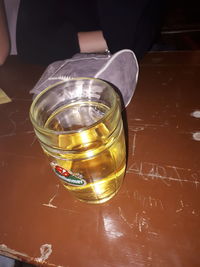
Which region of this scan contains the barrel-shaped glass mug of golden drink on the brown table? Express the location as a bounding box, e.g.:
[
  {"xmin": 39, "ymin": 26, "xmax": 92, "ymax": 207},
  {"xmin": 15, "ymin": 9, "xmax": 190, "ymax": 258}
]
[{"xmin": 30, "ymin": 78, "xmax": 126, "ymax": 203}]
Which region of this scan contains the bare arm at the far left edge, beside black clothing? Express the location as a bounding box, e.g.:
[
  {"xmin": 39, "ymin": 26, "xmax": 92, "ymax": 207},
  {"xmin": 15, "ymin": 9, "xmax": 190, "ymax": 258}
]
[{"xmin": 0, "ymin": 0, "xmax": 10, "ymax": 66}]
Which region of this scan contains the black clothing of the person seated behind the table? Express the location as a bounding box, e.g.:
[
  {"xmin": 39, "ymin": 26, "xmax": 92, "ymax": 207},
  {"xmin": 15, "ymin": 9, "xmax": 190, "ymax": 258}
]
[{"xmin": 17, "ymin": 0, "xmax": 165, "ymax": 64}]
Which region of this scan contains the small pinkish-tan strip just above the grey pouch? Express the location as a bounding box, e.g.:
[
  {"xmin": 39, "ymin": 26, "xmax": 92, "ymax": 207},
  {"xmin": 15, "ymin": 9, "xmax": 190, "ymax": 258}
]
[{"xmin": 78, "ymin": 31, "xmax": 108, "ymax": 53}]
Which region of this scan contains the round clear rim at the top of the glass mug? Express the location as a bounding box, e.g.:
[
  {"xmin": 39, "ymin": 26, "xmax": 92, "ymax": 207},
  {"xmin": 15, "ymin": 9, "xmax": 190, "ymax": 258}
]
[{"xmin": 29, "ymin": 77, "xmax": 117, "ymax": 135}]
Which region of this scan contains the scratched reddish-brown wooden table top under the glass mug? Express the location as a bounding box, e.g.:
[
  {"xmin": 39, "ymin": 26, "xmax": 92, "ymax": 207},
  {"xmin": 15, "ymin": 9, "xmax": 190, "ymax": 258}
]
[{"xmin": 0, "ymin": 51, "xmax": 200, "ymax": 267}]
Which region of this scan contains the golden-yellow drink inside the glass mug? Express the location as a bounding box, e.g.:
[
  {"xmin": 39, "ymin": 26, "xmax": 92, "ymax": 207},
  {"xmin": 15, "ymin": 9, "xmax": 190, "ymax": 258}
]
[{"xmin": 42, "ymin": 101, "xmax": 126, "ymax": 203}]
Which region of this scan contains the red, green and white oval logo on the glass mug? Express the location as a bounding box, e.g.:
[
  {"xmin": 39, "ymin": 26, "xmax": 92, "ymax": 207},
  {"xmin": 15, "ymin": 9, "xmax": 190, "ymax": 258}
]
[{"xmin": 51, "ymin": 163, "xmax": 86, "ymax": 186}]
